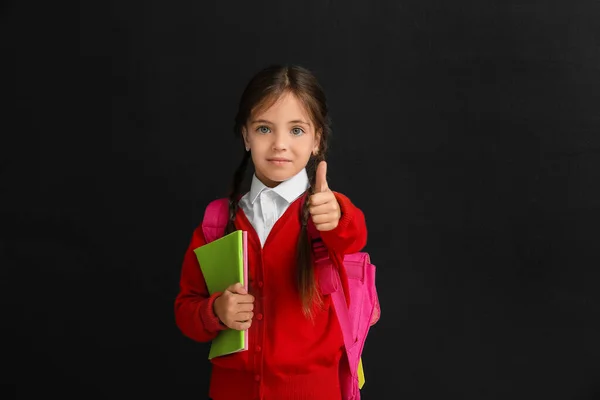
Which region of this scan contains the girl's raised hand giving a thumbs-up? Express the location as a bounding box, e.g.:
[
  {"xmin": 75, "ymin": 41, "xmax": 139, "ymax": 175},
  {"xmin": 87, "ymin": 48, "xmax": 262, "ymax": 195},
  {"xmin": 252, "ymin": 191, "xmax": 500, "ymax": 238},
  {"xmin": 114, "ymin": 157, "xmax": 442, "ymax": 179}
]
[{"xmin": 310, "ymin": 161, "xmax": 342, "ymax": 231}]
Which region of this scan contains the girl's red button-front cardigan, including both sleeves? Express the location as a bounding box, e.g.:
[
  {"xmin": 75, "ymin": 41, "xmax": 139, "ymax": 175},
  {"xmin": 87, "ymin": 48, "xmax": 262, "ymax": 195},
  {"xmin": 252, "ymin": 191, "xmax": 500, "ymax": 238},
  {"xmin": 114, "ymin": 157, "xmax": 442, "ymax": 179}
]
[{"xmin": 175, "ymin": 193, "xmax": 367, "ymax": 400}]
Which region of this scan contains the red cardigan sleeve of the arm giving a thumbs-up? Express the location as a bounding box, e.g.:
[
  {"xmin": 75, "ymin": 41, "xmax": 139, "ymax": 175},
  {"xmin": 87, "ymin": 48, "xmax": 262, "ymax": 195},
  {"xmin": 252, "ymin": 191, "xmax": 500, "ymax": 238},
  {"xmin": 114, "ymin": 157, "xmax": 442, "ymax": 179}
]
[{"xmin": 319, "ymin": 192, "xmax": 367, "ymax": 254}]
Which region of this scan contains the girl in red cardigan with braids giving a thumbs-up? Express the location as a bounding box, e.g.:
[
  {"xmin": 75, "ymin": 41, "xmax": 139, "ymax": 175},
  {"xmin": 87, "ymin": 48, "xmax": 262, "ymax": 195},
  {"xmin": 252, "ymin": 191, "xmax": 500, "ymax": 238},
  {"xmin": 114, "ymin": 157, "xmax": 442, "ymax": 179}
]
[{"xmin": 175, "ymin": 66, "xmax": 367, "ymax": 400}]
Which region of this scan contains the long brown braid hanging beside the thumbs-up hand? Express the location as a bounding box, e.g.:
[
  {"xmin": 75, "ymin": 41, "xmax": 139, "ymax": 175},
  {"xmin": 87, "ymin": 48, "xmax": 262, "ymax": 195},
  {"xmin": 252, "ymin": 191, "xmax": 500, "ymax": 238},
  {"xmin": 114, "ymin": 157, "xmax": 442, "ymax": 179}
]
[{"xmin": 297, "ymin": 153, "xmax": 323, "ymax": 318}]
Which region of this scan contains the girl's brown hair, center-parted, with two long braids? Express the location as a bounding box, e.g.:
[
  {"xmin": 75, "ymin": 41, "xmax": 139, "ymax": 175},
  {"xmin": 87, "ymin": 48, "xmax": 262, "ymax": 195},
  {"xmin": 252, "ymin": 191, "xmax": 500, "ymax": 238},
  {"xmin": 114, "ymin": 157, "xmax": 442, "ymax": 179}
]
[{"xmin": 226, "ymin": 65, "xmax": 331, "ymax": 317}]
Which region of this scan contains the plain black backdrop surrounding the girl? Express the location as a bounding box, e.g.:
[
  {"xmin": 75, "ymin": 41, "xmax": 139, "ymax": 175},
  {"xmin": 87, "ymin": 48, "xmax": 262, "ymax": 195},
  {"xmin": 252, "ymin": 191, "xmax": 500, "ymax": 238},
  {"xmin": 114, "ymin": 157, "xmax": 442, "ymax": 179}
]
[{"xmin": 0, "ymin": 0, "xmax": 600, "ymax": 399}]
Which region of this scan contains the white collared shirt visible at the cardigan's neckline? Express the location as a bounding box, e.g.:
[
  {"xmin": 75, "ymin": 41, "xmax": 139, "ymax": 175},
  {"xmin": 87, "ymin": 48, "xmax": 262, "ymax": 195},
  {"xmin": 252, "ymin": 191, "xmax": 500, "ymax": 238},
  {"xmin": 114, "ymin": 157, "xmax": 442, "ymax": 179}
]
[{"xmin": 239, "ymin": 169, "xmax": 309, "ymax": 246}]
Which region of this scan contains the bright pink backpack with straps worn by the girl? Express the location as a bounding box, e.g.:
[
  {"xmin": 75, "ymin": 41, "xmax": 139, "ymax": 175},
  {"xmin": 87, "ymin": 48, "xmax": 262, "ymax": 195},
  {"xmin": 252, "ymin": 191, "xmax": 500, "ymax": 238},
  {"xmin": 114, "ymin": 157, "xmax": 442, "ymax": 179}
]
[{"xmin": 202, "ymin": 198, "xmax": 381, "ymax": 400}]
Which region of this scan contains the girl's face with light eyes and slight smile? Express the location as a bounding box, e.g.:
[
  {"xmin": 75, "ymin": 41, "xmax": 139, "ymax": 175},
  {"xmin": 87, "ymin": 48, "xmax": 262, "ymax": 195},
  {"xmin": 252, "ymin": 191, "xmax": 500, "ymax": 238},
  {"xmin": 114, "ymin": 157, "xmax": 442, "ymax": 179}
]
[{"xmin": 242, "ymin": 93, "xmax": 319, "ymax": 187}]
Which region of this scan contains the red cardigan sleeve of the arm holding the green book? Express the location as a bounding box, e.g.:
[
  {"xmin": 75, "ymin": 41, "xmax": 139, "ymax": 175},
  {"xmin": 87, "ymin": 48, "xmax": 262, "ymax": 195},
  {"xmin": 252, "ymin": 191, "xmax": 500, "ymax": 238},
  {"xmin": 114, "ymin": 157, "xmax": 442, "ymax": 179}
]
[{"xmin": 175, "ymin": 226, "xmax": 227, "ymax": 342}]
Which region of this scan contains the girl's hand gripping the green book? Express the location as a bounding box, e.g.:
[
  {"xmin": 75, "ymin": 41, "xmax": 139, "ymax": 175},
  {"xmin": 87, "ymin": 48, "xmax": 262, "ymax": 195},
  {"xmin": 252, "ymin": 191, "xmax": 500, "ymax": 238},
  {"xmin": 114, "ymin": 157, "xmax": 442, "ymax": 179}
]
[{"xmin": 213, "ymin": 283, "xmax": 254, "ymax": 331}]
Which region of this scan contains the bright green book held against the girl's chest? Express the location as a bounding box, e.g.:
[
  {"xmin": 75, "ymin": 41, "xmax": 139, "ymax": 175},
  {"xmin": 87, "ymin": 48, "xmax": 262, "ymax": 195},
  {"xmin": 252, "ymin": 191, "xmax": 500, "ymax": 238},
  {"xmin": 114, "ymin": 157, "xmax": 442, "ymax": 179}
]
[{"xmin": 194, "ymin": 230, "xmax": 248, "ymax": 360}]
